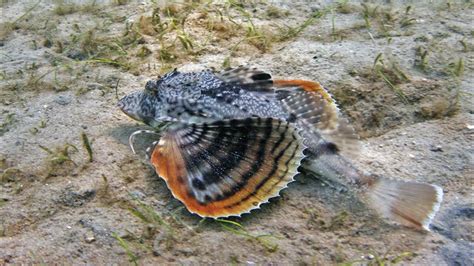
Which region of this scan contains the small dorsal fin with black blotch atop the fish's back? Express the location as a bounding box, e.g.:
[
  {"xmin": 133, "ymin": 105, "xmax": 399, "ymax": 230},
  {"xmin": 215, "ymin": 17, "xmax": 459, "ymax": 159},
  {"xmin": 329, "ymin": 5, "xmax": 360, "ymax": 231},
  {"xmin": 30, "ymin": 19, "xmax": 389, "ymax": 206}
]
[{"xmin": 216, "ymin": 66, "xmax": 273, "ymax": 91}]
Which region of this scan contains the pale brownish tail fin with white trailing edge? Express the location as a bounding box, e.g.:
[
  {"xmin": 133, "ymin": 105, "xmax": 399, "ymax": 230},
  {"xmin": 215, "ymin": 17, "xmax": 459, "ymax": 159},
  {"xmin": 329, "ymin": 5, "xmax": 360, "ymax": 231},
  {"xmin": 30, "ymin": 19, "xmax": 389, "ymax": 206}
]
[{"xmin": 368, "ymin": 178, "xmax": 443, "ymax": 231}]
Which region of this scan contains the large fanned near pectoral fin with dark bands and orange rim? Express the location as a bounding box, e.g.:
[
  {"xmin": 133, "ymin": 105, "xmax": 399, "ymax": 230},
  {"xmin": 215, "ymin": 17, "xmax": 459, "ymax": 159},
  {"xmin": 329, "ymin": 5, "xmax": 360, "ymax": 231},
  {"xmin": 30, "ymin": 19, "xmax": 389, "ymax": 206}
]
[{"xmin": 150, "ymin": 118, "xmax": 304, "ymax": 218}]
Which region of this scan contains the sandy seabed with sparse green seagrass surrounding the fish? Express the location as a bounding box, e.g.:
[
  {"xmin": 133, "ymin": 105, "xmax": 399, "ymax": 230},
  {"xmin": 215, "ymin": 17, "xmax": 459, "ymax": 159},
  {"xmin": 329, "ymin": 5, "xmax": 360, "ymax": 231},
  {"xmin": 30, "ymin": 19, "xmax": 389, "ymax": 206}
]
[{"xmin": 0, "ymin": 1, "xmax": 474, "ymax": 265}]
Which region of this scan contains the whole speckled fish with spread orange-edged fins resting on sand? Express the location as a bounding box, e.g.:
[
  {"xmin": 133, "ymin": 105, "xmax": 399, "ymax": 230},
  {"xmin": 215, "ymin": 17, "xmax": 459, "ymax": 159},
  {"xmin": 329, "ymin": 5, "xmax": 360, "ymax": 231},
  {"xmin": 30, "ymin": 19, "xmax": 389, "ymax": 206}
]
[{"xmin": 118, "ymin": 66, "xmax": 443, "ymax": 231}]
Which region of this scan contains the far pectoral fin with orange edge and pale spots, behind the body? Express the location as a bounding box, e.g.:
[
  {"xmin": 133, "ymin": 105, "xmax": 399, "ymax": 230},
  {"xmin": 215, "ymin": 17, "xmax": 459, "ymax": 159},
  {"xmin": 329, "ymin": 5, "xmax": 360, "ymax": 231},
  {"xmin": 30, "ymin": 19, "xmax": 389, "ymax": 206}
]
[{"xmin": 274, "ymin": 80, "xmax": 359, "ymax": 157}]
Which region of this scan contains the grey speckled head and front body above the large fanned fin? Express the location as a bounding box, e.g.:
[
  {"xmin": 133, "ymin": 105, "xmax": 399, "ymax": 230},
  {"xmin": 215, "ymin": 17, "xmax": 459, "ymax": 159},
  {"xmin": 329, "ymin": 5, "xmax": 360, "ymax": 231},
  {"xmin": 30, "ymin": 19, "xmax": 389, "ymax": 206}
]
[{"xmin": 119, "ymin": 70, "xmax": 287, "ymax": 126}]
